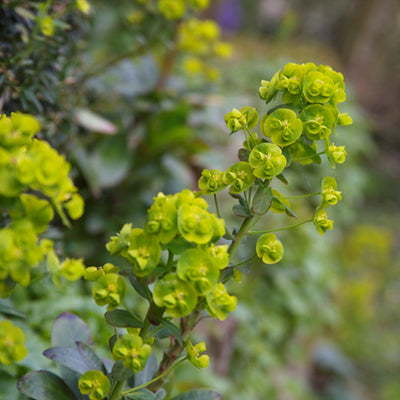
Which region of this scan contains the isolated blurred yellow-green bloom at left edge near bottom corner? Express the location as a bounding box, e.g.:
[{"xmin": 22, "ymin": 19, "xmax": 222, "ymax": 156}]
[{"xmin": 0, "ymin": 320, "xmax": 28, "ymax": 364}]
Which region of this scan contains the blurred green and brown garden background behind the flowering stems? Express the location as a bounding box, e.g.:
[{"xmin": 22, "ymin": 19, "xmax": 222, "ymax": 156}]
[{"xmin": 0, "ymin": 0, "xmax": 400, "ymax": 400}]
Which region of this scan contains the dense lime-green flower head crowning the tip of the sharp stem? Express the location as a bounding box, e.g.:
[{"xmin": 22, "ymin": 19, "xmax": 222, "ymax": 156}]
[{"xmin": 259, "ymin": 63, "xmax": 352, "ymax": 166}]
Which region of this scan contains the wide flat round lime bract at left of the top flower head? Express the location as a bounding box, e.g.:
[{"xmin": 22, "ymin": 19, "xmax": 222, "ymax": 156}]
[{"xmin": 260, "ymin": 108, "xmax": 303, "ymax": 147}]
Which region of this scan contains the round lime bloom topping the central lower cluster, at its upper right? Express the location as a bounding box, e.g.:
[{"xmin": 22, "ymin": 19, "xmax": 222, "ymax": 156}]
[{"xmin": 178, "ymin": 205, "xmax": 215, "ymax": 244}]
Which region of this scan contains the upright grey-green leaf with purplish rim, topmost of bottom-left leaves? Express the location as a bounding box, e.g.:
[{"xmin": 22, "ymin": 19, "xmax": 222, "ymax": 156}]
[{"xmin": 51, "ymin": 312, "xmax": 93, "ymax": 347}]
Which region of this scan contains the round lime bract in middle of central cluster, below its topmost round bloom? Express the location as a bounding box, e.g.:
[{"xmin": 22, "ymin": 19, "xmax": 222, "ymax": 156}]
[{"xmin": 176, "ymin": 249, "xmax": 219, "ymax": 296}]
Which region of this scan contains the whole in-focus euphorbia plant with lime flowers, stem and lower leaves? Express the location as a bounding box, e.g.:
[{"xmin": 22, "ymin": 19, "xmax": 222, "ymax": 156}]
[{"xmin": 19, "ymin": 63, "xmax": 351, "ymax": 400}]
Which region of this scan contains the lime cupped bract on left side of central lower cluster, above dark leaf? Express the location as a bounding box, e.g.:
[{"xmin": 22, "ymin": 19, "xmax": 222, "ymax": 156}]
[{"xmin": 126, "ymin": 228, "xmax": 161, "ymax": 277}]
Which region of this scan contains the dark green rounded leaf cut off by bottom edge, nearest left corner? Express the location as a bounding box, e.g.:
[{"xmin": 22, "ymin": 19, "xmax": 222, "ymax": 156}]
[{"xmin": 17, "ymin": 371, "xmax": 76, "ymax": 400}]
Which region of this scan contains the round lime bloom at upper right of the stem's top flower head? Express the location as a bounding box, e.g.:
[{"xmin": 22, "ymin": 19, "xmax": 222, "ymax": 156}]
[{"xmin": 303, "ymin": 71, "xmax": 336, "ymax": 103}]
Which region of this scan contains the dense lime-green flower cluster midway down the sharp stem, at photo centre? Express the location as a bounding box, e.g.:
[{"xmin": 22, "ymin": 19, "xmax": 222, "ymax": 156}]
[{"xmin": 106, "ymin": 190, "xmax": 236, "ymax": 319}]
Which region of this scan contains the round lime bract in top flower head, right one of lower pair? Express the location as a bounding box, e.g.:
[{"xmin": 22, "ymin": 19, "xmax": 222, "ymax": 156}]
[{"xmin": 299, "ymin": 104, "xmax": 335, "ymax": 140}]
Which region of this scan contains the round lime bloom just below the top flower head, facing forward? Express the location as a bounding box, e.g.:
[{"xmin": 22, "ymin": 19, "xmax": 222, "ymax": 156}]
[{"xmin": 249, "ymin": 143, "xmax": 286, "ymax": 179}]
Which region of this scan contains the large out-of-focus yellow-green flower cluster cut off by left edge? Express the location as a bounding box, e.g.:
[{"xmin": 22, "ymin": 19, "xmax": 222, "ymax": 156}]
[{"xmin": 0, "ymin": 113, "xmax": 83, "ymax": 297}]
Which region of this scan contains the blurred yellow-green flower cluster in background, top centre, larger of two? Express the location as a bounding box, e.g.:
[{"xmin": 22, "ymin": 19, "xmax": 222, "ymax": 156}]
[{"xmin": 178, "ymin": 18, "xmax": 232, "ymax": 80}]
